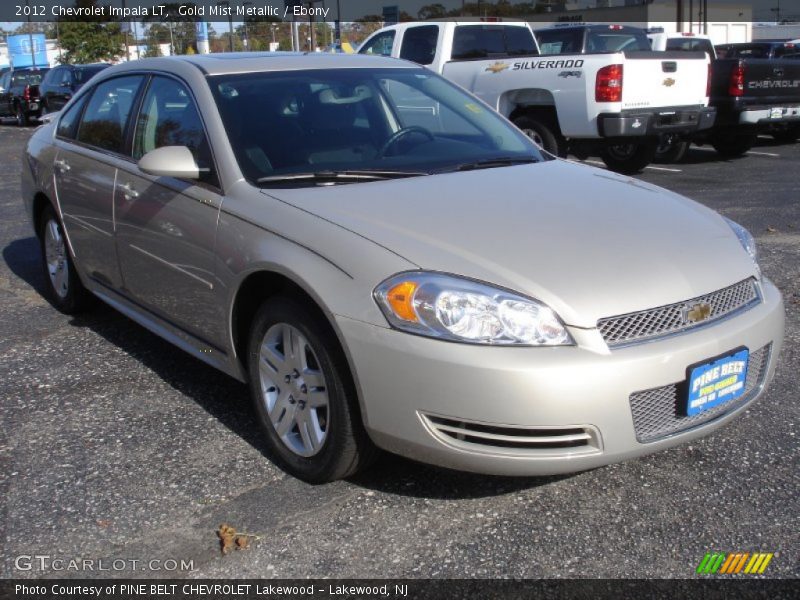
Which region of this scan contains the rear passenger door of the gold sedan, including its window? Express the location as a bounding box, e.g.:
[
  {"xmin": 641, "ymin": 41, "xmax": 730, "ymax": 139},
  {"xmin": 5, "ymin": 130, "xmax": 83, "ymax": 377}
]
[{"xmin": 53, "ymin": 75, "xmax": 144, "ymax": 289}]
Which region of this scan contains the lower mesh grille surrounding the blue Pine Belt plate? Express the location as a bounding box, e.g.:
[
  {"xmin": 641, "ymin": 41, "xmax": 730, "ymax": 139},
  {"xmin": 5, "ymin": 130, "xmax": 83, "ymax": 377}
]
[{"xmin": 630, "ymin": 344, "xmax": 771, "ymax": 442}]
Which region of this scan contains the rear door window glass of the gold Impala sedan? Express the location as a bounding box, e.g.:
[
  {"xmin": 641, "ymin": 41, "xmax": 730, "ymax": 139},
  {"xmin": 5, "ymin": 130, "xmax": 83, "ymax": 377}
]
[{"xmin": 76, "ymin": 75, "xmax": 143, "ymax": 154}]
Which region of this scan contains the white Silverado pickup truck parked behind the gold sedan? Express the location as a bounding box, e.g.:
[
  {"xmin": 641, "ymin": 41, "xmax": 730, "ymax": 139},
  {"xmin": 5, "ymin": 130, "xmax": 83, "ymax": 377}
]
[{"xmin": 359, "ymin": 21, "xmax": 715, "ymax": 173}]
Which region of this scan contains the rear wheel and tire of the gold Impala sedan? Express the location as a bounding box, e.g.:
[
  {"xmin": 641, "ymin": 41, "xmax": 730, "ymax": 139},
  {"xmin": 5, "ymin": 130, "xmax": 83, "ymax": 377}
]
[{"xmin": 39, "ymin": 205, "xmax": 93, "ymax": 315}]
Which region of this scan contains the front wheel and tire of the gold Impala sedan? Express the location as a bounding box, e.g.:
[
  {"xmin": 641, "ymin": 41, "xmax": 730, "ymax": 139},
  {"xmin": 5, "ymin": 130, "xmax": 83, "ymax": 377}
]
[{"xmin": 247, "ymin": 297, "xmax": 377, "ymax": 483}]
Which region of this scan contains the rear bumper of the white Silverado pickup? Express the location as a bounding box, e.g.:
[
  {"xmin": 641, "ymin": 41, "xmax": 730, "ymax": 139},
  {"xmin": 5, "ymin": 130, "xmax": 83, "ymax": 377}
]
[{"xmin": 597, "ymin": 107, "xmax": 717, "ymax": 138}]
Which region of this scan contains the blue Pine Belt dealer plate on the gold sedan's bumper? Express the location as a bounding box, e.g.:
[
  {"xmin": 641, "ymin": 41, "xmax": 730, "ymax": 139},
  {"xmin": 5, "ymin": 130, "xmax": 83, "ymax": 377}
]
[{"xmin": 686, "ymin": 348, "xmax": 749, "ymax": 417}]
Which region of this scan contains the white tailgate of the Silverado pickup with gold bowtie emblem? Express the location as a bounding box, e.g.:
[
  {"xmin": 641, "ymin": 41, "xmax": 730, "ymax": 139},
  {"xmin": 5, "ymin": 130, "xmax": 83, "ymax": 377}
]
[{"xmin": 622, "ymin": 52, "xmax": 709, "ymax": 110}]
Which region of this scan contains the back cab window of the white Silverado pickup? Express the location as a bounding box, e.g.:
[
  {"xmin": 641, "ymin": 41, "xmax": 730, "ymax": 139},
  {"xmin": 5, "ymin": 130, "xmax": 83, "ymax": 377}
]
[{"xmin": 452, "ymin": 25, "xmax": 538, "ymax": 60}]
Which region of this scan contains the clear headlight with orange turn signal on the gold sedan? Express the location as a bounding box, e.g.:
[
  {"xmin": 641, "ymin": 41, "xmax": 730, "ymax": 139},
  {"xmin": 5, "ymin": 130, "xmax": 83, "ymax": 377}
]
[{"xmin": 375, "ymin": 272, "xmax": 574, "ymax": 346}]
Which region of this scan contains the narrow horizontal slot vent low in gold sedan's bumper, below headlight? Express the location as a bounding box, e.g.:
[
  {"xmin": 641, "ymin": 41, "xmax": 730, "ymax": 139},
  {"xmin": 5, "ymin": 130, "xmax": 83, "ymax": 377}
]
[{"xmin": 421, "ymin": 414, "xmax": 600, "ymax": 453}]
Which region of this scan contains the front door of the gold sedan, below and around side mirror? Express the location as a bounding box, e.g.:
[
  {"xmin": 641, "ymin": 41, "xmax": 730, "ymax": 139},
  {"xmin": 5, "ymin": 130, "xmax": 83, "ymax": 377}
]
[{"xmin": 114, "ymin": 75, "xmax": 225, "ymax": 347}]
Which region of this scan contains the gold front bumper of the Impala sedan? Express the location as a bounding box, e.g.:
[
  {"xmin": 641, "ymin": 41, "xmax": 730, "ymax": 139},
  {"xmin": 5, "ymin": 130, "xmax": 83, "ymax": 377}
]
[{"xmin": 337, "ymin": 280, "xmax": 784, "ymax": 475}]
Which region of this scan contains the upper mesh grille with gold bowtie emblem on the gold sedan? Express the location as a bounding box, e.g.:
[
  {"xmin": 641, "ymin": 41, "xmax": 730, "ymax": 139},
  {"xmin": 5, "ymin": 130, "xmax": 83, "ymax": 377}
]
[{"xmin": 597, "ymin": 278, "xmax": 760, "ymax": 347}]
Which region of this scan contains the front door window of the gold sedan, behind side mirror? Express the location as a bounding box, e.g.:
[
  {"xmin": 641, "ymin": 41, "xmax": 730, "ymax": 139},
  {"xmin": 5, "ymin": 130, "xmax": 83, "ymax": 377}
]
[{"xmin": 133, "ymin": 77, "xmax": 216, "ymax": 184}]
